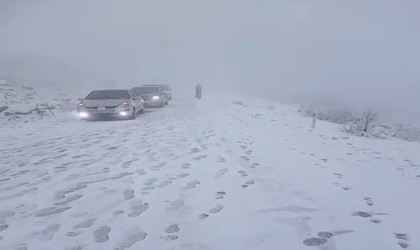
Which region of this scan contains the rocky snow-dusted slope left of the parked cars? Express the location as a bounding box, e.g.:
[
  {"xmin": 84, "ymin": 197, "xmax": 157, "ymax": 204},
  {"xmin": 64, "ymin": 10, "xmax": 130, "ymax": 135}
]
[{"xmin": 0, "ymin": 80, "xmax": 75, "ymax": 123}]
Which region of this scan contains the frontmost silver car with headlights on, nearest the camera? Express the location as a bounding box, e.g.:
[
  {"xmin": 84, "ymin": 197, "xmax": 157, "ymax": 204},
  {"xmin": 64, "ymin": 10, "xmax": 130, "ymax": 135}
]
[{"xmin": 77, "ymin": 90, "xmax": 144, "ymax": 120}]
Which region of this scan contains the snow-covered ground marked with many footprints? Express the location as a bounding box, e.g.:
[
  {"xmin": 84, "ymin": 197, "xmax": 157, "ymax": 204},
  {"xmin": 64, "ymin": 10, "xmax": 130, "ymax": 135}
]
[{"xmin": 0, "ymin": 95, "xmax": 420, "ymax": 250}]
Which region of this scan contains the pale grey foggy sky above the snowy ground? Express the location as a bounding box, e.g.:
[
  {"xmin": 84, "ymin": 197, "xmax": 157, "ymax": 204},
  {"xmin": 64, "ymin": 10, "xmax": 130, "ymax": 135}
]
[{"xmin": 0, "ymin": 0, "xmax": 420, "ymax": 122}]
